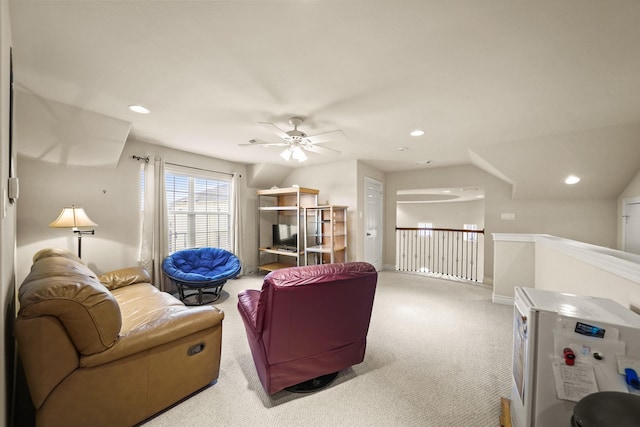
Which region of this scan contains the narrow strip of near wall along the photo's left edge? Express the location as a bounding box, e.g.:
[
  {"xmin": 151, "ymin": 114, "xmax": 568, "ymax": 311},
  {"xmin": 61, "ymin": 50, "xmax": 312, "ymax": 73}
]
[{"xmin": 0, "ymin": 1, "xmax": 18, "ymax": 424}]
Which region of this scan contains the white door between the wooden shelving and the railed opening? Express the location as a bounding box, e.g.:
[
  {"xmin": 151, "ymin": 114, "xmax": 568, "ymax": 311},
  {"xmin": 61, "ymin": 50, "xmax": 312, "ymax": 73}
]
[{"xmin": 364, "ymin": 176, "xmax": 382, "ymax": 271}]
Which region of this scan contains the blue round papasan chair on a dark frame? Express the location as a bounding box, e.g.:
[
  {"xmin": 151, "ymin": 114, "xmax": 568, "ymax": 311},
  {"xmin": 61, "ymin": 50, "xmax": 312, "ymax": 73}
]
[{"xmin": 162, "ymin": 248, "xmax": 242, "ymax": 305}]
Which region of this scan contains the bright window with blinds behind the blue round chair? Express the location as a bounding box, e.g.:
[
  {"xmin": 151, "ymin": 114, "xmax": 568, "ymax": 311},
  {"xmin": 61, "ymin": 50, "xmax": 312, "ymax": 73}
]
[{"xmin": 165, "ymin": 168, "xmax": 231, "ymax": 253}]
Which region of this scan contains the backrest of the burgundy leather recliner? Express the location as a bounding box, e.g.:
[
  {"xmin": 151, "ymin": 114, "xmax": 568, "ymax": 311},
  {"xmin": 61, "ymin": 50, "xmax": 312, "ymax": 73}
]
[{"xmin": 257, "ymin": 263, "xmax": 377, "ymax": 364}]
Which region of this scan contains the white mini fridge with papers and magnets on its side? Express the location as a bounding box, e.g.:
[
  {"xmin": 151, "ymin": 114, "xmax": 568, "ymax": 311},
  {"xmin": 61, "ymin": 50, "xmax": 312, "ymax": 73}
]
[{"xmin": 510, "ymin": 288, "xmax": 640, "ymax": 427}]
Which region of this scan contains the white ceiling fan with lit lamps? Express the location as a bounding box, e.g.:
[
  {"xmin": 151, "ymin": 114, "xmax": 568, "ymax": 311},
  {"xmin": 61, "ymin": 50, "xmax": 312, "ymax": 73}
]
[{"xmin": 239, "ymin": 117, "xmax": 344, "ymax": 162}]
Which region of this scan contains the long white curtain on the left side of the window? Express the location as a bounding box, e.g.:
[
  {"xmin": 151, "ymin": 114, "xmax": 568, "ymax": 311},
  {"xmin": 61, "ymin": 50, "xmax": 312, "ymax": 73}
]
[{"xmin": 140, "ymin": 157, "xmax": 169, "ymax": 291}]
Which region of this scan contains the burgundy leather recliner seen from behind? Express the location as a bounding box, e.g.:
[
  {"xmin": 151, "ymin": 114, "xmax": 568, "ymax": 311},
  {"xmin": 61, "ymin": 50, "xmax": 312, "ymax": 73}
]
[{"xmin": 238, "ymin": 262, "xmax": 378, "ymax": 394}]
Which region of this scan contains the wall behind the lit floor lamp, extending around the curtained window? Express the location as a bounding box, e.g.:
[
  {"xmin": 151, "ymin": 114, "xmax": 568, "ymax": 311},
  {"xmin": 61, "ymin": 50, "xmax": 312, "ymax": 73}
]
[{"xmin": 17, "ymin": 141, "xmax": 255, "ymax": 283}]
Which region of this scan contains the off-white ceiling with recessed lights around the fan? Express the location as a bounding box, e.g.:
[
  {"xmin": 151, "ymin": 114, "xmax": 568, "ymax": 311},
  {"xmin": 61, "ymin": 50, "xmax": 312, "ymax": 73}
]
[{"xmin": 9, "ymin": 0, "xmax": 640, "ymax": 199}]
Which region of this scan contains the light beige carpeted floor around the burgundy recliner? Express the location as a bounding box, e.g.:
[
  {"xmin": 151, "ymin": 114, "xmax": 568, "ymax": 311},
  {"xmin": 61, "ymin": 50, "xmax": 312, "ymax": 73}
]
[{"xmin": 144, "ymin": 272, "xmax": 513, "ymax": 427}]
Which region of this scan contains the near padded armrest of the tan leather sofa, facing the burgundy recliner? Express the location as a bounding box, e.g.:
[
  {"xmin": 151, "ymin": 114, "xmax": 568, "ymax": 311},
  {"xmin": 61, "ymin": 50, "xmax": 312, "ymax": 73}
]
[{"xmin": 80, "ymin": 306, "xmax": 224, "ymax": 367}]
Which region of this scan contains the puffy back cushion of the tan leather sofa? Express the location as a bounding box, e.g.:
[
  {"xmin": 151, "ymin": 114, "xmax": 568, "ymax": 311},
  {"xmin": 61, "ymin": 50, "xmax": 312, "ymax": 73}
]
[{"xmin": 18, "ymin": 249, "xmax": 122, "ymax": 355}]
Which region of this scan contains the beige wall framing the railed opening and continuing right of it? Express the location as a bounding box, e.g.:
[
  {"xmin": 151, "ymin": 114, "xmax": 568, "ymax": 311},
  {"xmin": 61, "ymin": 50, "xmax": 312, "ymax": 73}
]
[{"xmin": 384, "ymin": 165, "xmax": 617, "ymax": 283}]
